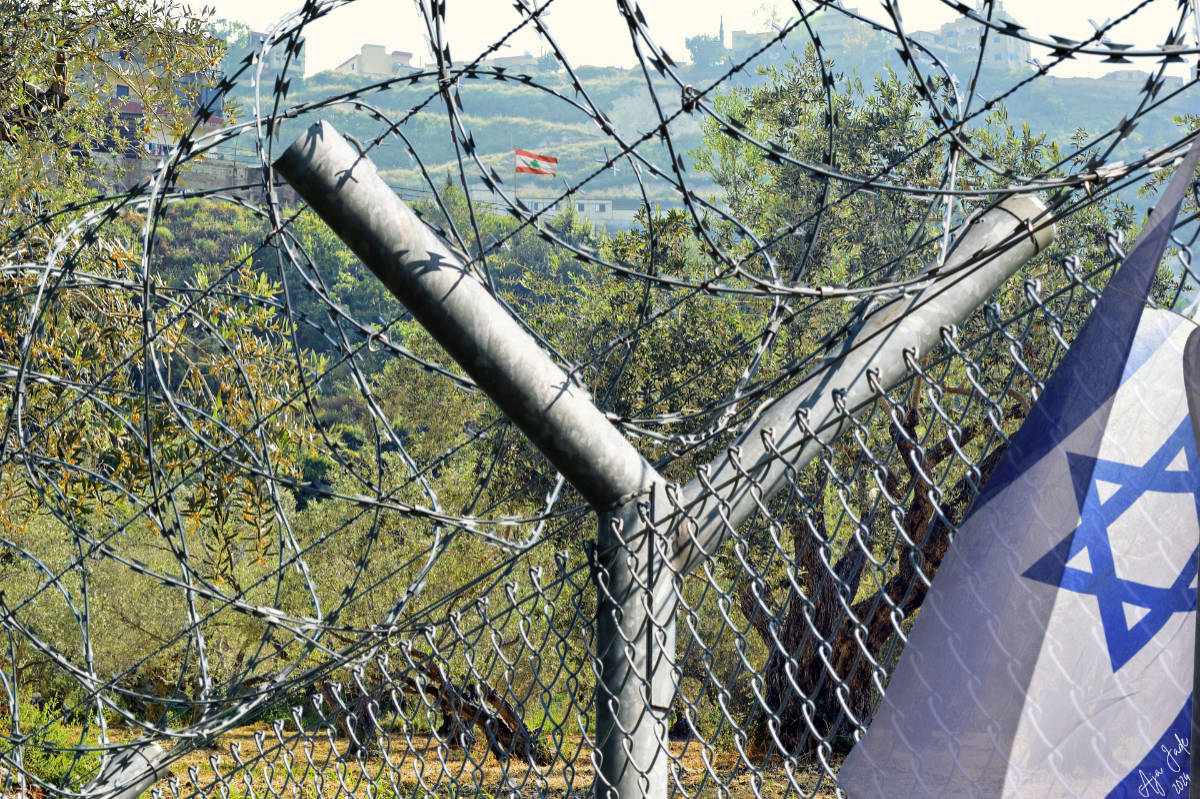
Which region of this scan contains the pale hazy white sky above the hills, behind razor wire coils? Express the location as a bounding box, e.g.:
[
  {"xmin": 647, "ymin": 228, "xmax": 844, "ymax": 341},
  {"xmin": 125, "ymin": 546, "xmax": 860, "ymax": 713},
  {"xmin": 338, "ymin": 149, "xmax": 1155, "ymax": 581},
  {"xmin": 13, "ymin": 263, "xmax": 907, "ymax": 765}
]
[{"xmin": 206, "ymin": 0, "xmax": 1195, "ymax": 76}]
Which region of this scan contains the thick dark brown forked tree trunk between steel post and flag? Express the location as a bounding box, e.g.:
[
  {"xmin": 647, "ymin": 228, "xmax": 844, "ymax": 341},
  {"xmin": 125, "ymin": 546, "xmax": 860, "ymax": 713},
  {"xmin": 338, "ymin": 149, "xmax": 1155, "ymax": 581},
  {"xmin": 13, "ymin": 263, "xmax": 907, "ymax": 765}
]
[{"xmin": 738, "ymin": 400, "xmax": 1019, "ymax": 758}]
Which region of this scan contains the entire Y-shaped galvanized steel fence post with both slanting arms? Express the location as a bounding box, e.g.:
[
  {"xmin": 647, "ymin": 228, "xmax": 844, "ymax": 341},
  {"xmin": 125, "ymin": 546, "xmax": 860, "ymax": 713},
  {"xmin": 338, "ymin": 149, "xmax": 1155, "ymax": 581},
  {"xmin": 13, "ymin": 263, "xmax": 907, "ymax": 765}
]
[{"xmin": 275, "ymin": 122, "xmax": 1054, "ymax": 799}]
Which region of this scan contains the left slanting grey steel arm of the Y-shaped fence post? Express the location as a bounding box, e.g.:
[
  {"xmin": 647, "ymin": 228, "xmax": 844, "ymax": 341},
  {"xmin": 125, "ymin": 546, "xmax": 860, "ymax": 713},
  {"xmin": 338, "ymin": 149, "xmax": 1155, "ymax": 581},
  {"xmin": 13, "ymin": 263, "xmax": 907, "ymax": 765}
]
[{"xmin": 275, "ymin": 122, "xmax": 660, "ymax": 509}]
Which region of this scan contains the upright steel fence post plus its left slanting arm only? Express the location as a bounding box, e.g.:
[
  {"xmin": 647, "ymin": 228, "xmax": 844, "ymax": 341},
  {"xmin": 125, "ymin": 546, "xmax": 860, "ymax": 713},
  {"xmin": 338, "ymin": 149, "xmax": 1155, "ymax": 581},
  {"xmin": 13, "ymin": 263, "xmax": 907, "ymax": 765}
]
[{"xmin": 275, "ymin": 122, "xmax": 674, "ymax": 799}]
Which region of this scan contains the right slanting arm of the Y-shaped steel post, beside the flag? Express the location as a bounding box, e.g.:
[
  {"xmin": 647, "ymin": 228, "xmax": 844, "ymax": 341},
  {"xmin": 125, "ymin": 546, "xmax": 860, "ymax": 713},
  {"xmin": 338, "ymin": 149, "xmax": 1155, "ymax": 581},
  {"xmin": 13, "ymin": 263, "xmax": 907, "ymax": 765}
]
[{"xmin": 673, "ymin": 194, "xmax": 1055, "ymax": 575}]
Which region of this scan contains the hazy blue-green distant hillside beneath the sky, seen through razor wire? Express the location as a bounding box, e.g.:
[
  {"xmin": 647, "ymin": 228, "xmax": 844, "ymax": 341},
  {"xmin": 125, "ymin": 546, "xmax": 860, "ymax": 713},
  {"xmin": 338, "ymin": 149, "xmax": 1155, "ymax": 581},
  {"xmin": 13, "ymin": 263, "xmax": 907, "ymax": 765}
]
[{"xmin": 213, "ymin": 14, "xmax": 1188, "ymax": 218}]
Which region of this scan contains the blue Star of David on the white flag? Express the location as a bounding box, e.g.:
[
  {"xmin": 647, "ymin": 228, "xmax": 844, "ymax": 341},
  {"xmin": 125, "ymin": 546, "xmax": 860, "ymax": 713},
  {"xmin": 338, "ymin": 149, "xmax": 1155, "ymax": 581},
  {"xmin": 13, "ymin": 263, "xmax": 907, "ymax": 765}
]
[{"xmin": 1022, "ymin": 417, "xmax": 1200, "ymax": 673}]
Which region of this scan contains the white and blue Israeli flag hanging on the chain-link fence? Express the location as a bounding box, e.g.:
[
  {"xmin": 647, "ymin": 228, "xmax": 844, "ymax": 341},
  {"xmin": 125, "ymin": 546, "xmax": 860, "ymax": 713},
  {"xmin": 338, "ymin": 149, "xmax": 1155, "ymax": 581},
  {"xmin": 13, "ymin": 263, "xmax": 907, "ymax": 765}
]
[{"xmin": 839, "ymin": 139, "xmax": 1200, "ymax": 799}]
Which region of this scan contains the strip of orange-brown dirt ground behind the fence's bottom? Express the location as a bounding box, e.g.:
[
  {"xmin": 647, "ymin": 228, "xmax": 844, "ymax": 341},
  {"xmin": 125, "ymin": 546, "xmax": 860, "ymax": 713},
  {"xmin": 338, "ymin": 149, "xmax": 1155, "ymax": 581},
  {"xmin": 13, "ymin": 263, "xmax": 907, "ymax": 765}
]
[{"xmin": 158, "ymin": 723, "xmax": 840, "ymax": 799}]
